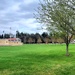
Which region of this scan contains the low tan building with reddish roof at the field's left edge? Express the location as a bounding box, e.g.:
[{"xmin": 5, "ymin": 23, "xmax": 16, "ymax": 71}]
[{"xmin": 0, "ymin": 38, "xmax": 23, "ymax": 46}]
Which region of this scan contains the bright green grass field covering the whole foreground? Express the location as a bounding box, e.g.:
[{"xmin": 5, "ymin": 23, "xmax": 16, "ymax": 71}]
[{"xmin": 0, "ymin": 44, "xmax": 75, "ymax": 75}]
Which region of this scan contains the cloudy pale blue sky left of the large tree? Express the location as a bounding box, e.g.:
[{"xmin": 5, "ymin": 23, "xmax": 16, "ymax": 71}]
[{"xmin": 0, "ymin": 0, "xmax": 45, "ymax": 33}]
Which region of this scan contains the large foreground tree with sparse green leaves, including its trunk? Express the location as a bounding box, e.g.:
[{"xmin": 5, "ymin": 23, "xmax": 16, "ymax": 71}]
[{"xmin": 35, "ymin": 0, "xmax": 75, "ymax": 56}]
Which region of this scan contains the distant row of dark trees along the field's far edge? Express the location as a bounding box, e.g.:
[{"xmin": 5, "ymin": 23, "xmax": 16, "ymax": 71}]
[{"xmin": 0, "ymin": 31, "xmax": 74, "ymax": 44}]
